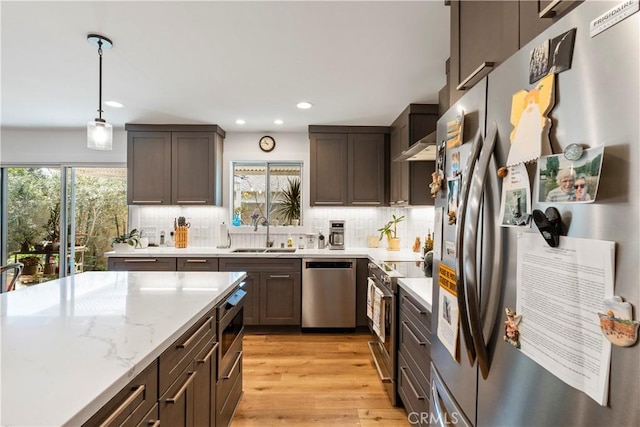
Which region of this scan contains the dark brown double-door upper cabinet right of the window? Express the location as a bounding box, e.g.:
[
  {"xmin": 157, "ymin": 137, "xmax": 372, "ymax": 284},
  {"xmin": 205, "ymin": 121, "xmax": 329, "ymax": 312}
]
[{"xmin": 309, "ymin": 126, "xmax": 389, "ymax": 206}]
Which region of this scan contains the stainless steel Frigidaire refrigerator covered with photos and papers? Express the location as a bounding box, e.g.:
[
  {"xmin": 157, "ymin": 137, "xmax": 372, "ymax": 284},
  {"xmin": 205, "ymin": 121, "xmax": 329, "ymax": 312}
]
[{"xmin": 431, "ymin": 1, "xmax": 640, "ymax": 426}]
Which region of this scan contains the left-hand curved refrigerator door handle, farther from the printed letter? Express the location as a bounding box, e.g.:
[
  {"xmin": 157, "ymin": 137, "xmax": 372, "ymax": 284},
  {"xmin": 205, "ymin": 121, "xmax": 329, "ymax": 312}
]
[{"xmin": 456, "ymin": 129, "xmax": 482, "ymax": 366}]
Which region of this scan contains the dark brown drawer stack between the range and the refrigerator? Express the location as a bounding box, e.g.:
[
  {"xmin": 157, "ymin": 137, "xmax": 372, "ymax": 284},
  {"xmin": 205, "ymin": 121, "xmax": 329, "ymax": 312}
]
[{"xmin": 398, "ymin": 288, "xmax": 431, "ymax": 426}]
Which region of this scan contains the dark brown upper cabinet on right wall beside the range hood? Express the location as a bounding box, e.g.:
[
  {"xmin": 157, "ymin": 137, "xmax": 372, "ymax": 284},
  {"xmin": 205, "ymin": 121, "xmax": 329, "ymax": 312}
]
[{"xmin": 389, "ymin": 104, "xmax": 438, "ymax": 206}]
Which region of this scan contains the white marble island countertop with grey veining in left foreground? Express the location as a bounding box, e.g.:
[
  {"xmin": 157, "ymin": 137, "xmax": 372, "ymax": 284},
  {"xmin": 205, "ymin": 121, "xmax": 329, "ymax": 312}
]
[{"xmin": 0, "ymin": 272, "xmax": 246, "ymax": 426}]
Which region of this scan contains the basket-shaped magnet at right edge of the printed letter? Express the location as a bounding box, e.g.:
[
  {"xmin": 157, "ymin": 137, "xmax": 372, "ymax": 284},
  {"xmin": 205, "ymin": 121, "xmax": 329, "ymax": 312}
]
[{"xmin": 598, "ymin": 296, "xmax": 640, "ymax": 347}]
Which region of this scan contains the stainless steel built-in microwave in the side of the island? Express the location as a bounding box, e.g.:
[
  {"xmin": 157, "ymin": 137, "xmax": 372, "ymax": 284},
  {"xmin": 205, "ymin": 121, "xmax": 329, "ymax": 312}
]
[{"xmin": 217, "ymin": 283, "xmax": 247, "ymax": 379}]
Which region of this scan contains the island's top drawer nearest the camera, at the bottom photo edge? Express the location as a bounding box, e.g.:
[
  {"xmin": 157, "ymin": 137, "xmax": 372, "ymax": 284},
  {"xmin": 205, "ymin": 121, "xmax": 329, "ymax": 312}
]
[{"xmin": 84, "ymin": 360, "xmax": 158, "ymax": 426}]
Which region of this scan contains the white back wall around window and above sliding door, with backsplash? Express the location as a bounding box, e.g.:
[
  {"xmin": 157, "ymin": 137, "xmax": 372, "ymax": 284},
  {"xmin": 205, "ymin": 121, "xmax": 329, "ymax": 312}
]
[{"xmin": 0, "ymin": 129, "xmax": 434, "ymax": 252}]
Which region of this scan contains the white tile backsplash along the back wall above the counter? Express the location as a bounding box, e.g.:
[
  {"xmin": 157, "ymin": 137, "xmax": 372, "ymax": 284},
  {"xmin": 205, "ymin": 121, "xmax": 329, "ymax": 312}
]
[{"xmin": 129, "ymin": 206, "xmax": 434, "ymax": 248}]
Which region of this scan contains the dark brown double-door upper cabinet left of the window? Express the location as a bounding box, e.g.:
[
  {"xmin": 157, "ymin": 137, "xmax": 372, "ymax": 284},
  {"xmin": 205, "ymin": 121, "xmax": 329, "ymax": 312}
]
[{"xmin": 125, "ymin": 124, "xmax": 225, "ymax": 205}]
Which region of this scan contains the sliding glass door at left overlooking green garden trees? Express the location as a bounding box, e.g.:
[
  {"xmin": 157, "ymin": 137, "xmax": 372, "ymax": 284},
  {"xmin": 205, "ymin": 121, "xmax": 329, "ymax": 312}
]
[{"xmin": 0, "ymin": 167, "xmax": 127, "ymax": 291}]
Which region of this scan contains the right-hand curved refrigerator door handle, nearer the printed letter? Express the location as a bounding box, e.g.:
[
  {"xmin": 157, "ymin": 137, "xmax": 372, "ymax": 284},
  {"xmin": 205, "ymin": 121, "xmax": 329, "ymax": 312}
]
[{"xmin": 461, "ymin": 122, "xmax": 498, "ymax": 379}]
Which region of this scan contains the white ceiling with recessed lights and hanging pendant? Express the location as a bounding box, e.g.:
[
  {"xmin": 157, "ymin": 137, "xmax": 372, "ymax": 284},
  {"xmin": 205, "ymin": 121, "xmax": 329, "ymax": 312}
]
[{"xmin": 0, "ymin": 0, "xmax": 449, "ymax": 132}]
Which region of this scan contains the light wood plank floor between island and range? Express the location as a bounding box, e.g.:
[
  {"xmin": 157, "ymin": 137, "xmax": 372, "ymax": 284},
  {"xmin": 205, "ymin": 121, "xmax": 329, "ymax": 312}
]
[{"xmin": 231, "ymin": 333, "xmax": 409, "ymax": 427}]
